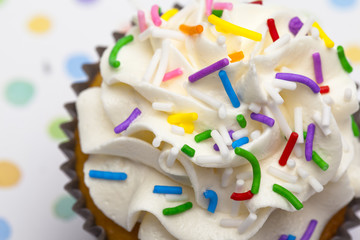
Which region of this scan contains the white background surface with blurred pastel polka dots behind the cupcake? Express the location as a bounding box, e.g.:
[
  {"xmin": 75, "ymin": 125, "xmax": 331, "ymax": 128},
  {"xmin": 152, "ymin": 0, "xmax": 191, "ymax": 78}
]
[{"xmin": 0, "ymin": 0, "xmax": 360, "ymax": 240}]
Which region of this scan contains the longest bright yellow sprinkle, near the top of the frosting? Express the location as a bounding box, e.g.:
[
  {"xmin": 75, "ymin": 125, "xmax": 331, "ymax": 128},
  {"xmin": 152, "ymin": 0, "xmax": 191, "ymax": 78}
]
[{"xmin": 208, "ymin": 14, "xmax": 262, "ymax": 41}]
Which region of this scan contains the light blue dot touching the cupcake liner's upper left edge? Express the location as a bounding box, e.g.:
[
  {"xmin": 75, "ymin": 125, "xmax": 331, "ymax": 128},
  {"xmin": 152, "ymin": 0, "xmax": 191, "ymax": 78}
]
[{"xmin": 66, "ymin": 54, "xmax": 92, "ymax": 82}]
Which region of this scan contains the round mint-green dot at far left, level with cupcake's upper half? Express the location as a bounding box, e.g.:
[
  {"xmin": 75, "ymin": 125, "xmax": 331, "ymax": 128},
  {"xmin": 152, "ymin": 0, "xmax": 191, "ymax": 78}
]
[{"xmin": 4, "ymin": 79, "xmax": 35, "ymax": 106}]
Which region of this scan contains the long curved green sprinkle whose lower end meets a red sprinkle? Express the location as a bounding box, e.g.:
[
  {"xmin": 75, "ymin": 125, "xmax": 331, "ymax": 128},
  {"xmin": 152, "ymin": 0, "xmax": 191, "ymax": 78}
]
[{"xmin": 235, "ymin": 147, "xmax": 261, "ymax": 194}]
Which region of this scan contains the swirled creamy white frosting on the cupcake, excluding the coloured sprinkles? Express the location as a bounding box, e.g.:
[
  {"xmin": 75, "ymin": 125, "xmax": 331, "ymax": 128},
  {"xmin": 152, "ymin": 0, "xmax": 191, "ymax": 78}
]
[{"xmin": 77, "ymin": 1, "xmax": 360, "ymax": 240}]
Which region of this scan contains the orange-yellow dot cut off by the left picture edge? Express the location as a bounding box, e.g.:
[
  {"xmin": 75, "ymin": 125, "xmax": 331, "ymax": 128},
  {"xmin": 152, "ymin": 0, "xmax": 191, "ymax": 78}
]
[{"xmin": 0, "ymin": 161, "xmax": 21, "ymax": 187}]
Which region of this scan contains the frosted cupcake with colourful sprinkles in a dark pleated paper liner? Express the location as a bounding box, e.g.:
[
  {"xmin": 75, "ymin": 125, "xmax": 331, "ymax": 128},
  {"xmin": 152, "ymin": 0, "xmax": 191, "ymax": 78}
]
[{"xmin": 62, "ymin": 1, "xmax": 360, "ymax": 240}]
